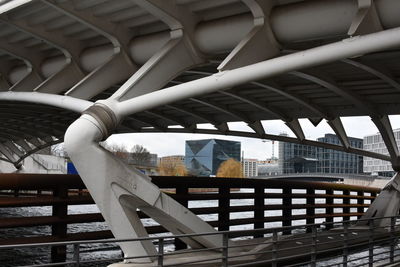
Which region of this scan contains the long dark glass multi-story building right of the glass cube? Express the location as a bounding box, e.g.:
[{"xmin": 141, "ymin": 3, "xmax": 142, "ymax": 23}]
[{"xmin": 279, "ymin": 134, "xmax": 363, "ymax": 173}]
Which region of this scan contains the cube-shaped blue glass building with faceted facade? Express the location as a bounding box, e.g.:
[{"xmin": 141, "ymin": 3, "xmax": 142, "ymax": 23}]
[{"xmin": 185, "ymin": 139, "xmax": 241, "ymax": 176}]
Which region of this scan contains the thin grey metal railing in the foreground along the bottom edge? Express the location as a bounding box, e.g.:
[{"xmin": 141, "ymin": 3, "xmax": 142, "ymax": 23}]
[{"xmin": 0, "ymin": 216, "xmax": 400, "ymax": 267}]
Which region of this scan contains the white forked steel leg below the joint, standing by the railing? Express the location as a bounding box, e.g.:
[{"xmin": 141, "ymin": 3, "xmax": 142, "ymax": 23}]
[{"xmin": 65, "ymin": 114, "xmax": 227, "ymax": 262}]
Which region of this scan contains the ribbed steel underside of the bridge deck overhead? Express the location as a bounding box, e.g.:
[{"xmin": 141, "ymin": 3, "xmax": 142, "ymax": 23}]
[{"xmin": 0, "ymin": 0, "xmax": 400, "ymax": 168}]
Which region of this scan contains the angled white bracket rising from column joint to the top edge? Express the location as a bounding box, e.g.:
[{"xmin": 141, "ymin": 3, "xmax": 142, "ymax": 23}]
[{"xmin": 112, "ymin": 0, "xmax": 205, "ymax": 101}]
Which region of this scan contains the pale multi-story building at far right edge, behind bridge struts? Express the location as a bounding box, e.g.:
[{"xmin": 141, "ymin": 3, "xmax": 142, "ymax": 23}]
[{"xmin": 364, "ymin": 129, "xmax": 400, "ymax": 177}]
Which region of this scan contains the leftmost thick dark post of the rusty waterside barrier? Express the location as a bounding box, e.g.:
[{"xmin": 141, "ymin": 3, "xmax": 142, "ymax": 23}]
[{"xmin": 51, "ymin": 186, "xmax": 68, "ymax": 262}]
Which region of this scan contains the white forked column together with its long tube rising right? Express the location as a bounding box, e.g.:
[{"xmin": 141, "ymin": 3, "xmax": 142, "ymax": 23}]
[{"xmin": 61, "ymin": 25, "xmax": 400, "ymax": 260}]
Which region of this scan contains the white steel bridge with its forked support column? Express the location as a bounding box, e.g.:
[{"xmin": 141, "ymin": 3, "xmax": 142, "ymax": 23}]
[{"xmin": 0, "ymin": 0, "xmax": 400, "ymax": 261}]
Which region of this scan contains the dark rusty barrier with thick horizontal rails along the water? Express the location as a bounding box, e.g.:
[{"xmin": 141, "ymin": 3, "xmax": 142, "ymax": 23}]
[{"xmin": 0, "ymin": 174, "xmax": 379, "ymax": 261}]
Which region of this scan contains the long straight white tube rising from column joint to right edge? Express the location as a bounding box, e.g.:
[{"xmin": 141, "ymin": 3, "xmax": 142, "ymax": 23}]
[{"xmin": 115, "ymin": 28, "xmax": 400, "ymax": 118}]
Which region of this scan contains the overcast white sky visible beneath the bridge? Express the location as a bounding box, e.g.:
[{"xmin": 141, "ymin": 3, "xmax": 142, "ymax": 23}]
[{"xmin": 107, "ymin": 115, "xmax": 400, "ymax": 160}]
